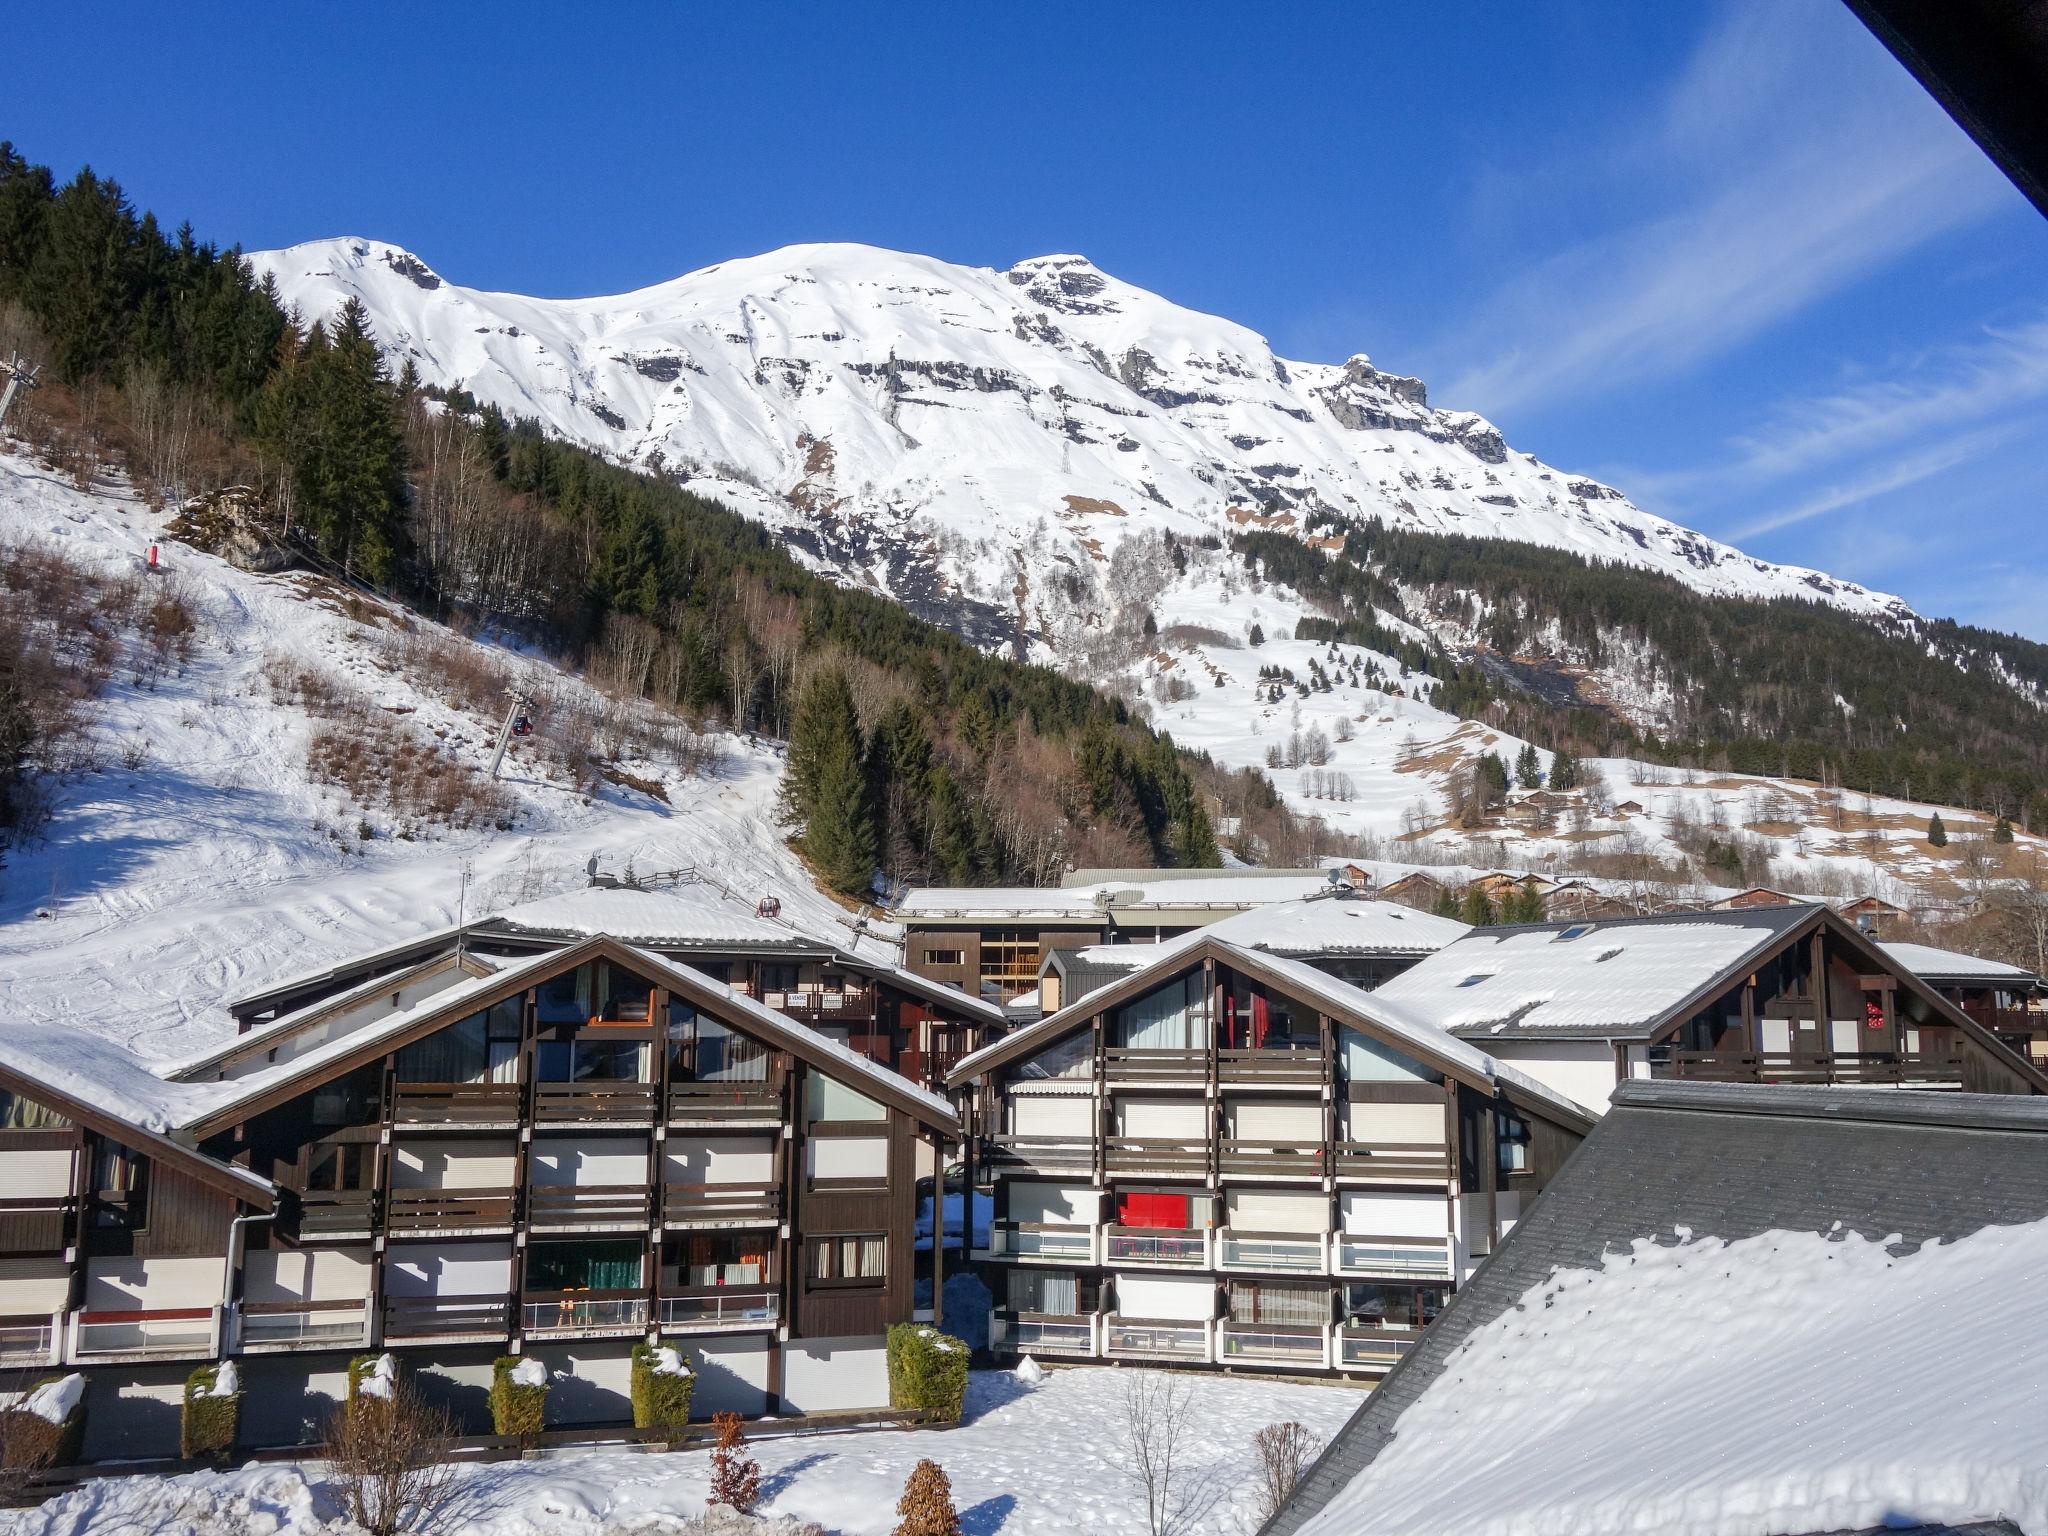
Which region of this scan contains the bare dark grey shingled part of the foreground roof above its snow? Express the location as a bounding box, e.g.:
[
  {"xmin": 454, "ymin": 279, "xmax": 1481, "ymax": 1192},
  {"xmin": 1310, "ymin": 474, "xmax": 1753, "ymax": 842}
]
[{"xmin": 1262, "ymin": 1081, "xmax": 2048, "ymax": 1536}]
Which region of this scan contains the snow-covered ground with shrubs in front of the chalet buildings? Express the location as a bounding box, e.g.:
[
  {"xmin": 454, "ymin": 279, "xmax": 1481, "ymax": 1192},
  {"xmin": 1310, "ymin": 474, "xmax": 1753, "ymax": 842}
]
[{"xmin": 0, "ymin": 1368, "xmax": 1364, "ymax": 1536}]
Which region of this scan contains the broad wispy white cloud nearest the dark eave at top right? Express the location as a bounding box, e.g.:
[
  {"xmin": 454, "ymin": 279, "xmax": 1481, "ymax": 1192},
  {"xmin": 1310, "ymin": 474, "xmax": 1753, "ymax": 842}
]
[{"xmin": 1444, "ymin": 0, "xmax": 2009, "ymax": 414}]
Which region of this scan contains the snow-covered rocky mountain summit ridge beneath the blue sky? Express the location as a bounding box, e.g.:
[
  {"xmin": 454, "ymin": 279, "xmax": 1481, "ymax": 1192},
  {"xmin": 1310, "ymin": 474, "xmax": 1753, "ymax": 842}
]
[{"xmin": 252, "ymin": 240, "xmax": 1907, "ymax": 664}]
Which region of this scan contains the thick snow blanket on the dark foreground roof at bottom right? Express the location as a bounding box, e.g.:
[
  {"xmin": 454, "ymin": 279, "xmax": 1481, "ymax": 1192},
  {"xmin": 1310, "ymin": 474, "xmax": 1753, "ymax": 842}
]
[{"xmin": 1300, "ymin": 1221, "xmax": 2048, "ymax": 1536}]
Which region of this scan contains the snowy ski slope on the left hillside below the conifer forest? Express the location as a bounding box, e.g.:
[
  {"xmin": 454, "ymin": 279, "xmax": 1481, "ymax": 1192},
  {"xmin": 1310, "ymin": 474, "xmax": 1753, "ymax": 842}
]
[{"xmin": 0, "ymin": 453, "xmax": 881, "ymax": 1059}]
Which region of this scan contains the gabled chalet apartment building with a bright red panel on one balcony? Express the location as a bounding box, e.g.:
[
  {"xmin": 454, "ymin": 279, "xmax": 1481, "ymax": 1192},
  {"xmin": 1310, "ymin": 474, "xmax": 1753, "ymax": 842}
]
[{"xmin": 950, "ymin": 933, "xmax": 1593, "ymax": 1376}]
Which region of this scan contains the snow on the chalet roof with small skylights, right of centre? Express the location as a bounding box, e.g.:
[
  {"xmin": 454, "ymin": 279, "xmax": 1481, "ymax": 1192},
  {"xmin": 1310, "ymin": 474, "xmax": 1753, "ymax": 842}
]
[{"xmin": 1372, "ymin": 922, "xmax": 1782, "ymax": 1034}]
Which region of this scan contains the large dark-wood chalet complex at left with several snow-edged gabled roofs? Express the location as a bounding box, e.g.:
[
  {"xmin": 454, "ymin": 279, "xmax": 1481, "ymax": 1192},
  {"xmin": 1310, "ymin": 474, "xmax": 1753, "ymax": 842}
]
[{"xmin": 0, "ymin": 889, "xmax": 993, "ymax": 1458}]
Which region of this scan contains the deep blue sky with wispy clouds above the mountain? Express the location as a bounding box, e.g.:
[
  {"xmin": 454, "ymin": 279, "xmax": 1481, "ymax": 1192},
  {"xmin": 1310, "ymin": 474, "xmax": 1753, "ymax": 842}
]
[{"xmin": 12, "ymin": 0, "xmax": 2048, "ymax": 639}]
